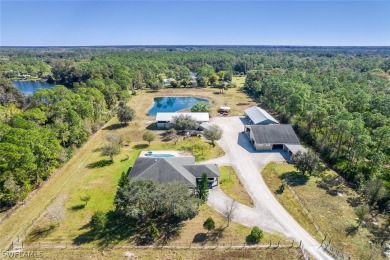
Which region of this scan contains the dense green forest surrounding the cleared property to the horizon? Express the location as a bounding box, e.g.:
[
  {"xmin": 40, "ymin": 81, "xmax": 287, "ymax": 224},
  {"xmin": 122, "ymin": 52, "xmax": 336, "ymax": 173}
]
[{"xmin": 0, "ymin": 46, "xmax": 390, "ymax": 213}]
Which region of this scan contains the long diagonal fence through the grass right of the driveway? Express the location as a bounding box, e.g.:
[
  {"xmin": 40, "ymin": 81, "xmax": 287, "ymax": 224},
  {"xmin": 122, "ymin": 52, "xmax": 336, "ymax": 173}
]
[{"xmin": 286, "ymin": 179, "xmax": 350, "ymax": 260}]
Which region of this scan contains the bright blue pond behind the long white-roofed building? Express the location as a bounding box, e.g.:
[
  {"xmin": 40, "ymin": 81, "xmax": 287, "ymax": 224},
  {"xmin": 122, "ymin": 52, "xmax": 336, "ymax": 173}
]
[{"xmin": 148, "ymin": 97, "xmax": 209, "ymax": 116}]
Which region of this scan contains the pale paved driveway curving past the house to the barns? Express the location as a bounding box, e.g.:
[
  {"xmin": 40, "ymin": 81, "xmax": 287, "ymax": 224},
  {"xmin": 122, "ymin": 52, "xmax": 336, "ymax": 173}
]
[{"xmin": 205, "ymin": 117, "xmax": 332, "ymax": 259}]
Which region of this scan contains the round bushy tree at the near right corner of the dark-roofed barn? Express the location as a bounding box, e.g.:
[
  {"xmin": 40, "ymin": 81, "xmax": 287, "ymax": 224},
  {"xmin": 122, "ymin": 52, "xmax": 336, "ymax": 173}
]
[{"xmin": 291, "ymin": 151, "xmax": 320, "ymax": 175}]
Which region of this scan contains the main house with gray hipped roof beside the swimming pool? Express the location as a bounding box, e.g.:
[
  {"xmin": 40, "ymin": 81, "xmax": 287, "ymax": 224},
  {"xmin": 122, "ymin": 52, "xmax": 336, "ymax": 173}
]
[{"xmin": 128, "ymin": 156, "xmax": 219, "ymax": 188}]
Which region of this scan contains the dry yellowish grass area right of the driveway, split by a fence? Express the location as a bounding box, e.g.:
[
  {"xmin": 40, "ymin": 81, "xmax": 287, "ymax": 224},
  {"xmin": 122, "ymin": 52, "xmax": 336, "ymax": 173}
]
[{"xmin": 262, "ymin": 163, "xmax": 372, "ymax": 259}]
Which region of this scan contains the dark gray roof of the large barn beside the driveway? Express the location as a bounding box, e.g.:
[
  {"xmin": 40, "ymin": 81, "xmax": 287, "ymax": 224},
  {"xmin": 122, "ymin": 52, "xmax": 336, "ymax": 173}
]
[{"xmin": 250, "ymin": 125, "xmax": 299, "ymax": 144}]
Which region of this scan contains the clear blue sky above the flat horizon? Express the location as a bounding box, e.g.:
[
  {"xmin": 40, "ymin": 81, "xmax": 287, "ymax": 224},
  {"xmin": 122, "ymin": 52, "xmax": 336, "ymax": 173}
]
[{"xmin": 0, "ymin": 0, "xmax": 390, "ymax": 46}]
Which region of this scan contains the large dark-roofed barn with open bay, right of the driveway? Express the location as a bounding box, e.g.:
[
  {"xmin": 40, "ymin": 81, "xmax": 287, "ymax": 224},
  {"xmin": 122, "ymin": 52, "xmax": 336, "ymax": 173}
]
[{"xmin": 245, "ymin": 124, "xmax": 306, "ymax": 155}]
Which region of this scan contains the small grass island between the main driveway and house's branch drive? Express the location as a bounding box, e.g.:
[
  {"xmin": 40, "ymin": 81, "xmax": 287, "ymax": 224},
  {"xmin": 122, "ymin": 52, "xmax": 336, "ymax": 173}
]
[{"xmin": 219, "ymin": 166, "xmax": 254, "ymax": 207}]
